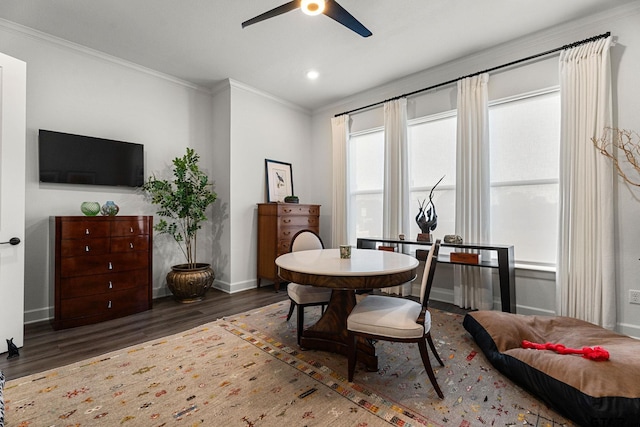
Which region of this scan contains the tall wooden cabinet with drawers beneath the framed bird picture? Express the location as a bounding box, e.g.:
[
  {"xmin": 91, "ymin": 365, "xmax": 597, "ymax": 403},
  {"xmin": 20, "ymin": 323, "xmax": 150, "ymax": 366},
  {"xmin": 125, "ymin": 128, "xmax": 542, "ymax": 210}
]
[{"xmin": 258, "ymin": 203, "xmax": 320, "ymax": 291}]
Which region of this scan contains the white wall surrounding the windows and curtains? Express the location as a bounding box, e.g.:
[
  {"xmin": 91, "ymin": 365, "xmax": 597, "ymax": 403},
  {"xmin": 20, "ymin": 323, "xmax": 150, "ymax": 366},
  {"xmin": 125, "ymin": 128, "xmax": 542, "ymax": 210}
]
[{"xmin": 311, "ymin": 3, "xmax": 640, "ymax": 337}]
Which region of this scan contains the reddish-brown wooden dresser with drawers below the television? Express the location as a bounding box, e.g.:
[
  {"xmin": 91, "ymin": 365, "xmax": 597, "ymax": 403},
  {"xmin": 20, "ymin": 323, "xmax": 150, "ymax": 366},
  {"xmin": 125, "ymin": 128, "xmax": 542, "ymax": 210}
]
[{"xmin": 49, "ymin": 216, "xmax": 153, "ymax": 329}]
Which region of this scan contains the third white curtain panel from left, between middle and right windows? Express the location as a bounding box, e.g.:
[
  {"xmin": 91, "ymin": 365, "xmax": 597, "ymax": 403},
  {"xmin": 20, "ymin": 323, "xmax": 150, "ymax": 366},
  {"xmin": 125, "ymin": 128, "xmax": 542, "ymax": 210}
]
[{"xmin": 453, "ymin": 73, "xmax": 493, "ymax": 310}]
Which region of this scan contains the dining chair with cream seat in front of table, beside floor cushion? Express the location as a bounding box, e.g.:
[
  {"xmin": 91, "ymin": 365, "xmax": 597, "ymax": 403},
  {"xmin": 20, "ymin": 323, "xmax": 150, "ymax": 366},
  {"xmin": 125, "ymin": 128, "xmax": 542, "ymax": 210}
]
[{"xmin": 347, "ymin": 240, "xmax": 444, "ymax": 399}]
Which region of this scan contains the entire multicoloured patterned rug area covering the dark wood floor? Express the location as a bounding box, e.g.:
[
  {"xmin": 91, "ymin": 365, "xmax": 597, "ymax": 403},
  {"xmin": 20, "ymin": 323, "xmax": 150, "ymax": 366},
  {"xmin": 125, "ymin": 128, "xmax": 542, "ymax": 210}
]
[{"xmin": 5, "ymin": 302, "xmax": 573, "ymax": 427}]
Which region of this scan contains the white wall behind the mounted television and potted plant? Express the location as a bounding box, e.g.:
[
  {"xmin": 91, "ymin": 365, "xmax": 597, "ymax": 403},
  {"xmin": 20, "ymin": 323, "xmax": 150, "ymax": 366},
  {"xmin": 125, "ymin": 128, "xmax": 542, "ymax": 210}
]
[{"xmin": 0, "ymin": 23, "xmax": 216, "ymax": 322}]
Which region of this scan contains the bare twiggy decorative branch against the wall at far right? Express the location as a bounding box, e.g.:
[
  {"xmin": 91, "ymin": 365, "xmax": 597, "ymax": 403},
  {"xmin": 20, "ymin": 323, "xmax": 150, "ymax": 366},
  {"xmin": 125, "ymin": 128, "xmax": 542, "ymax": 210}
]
[{"xmin": 591, "ymin": 127, "xmax": 640, "ymax": 187}]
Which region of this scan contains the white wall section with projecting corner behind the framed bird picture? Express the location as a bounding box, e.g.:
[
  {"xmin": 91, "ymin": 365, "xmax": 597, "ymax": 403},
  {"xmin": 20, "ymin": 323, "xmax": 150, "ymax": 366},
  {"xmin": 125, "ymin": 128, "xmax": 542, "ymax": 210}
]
[{"xmin": 214, "ymin": 80, "xmax": 312, "ymax": 293}]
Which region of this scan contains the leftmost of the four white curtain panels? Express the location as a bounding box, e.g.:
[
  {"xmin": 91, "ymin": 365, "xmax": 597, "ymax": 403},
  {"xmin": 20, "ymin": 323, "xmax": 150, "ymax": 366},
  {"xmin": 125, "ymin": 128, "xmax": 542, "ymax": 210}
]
[{"xmin": 330, "ymin": 114, "xmax": 349, "ymax": 248}]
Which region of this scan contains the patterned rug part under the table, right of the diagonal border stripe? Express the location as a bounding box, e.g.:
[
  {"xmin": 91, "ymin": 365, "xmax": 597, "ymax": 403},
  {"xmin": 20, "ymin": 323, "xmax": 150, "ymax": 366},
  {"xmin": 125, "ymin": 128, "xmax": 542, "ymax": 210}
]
[{"xmin": 229, "ymin": 301, "xmax": 575, "ymax": 427}]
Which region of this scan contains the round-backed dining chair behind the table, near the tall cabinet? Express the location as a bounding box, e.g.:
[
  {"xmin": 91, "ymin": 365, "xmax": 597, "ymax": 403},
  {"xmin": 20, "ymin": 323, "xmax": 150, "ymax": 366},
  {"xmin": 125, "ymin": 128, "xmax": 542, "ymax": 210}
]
[{"xmin": 287, "ymin": 230, "xmax": 331, "ymax": 345}]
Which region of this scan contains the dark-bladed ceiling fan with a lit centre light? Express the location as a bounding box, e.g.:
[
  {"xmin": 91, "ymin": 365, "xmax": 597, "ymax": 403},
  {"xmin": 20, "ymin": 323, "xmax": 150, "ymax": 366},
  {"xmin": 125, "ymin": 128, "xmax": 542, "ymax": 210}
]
[{"xmin": 242, "ymin": 0, "xmax": 372, "ymax": 37}]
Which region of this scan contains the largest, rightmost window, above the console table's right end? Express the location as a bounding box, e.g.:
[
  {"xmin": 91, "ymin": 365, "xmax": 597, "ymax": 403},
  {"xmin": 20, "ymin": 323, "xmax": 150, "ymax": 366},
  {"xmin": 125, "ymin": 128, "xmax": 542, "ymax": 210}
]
[{"xmin": 489, "ymin": 90, "xmax": 560, "ymax": 265}]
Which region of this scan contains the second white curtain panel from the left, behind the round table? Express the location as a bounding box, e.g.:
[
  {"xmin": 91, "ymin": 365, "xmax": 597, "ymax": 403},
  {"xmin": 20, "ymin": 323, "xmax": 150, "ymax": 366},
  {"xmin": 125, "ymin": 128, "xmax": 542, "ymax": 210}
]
[{"xmin": 382, "ymin": 98, "xmax": 411, "ymax": 296}]
